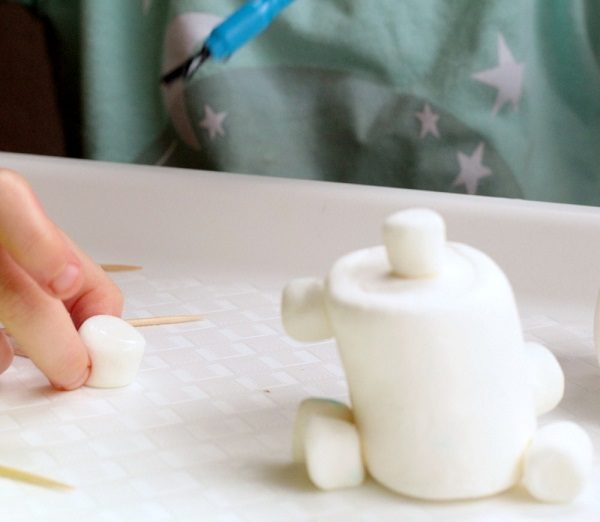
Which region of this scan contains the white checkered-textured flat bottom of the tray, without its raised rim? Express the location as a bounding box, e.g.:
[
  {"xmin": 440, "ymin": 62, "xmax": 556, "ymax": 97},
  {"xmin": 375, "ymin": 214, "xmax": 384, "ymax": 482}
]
[{"xmin": 0, "ymin": 270, "xmax": 600, "ymax": 522}]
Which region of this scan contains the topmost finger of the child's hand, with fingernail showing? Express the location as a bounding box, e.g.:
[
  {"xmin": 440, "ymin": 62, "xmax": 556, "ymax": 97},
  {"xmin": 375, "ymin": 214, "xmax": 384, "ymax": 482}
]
[{"xmin": 0, "ymin": 169, "xmax": 83, "ymax": 299}]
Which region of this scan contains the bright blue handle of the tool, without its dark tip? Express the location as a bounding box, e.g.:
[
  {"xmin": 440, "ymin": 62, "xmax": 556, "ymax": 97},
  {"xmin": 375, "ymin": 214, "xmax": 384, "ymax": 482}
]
[{"xmin": 204, "ymin": 0, "xmax": 293, "ymax": 60}]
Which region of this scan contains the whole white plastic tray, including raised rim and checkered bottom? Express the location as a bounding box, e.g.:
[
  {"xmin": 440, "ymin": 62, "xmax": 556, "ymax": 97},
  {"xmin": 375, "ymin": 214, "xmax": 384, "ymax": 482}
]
[{"xmin": 0, "ymin": 154, "xmax": 600, "ymax": 522}]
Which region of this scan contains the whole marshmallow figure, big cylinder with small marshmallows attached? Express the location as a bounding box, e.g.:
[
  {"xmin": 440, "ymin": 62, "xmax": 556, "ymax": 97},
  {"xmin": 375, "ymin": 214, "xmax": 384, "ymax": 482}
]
[{"xmin": 282, "ymin": 209, "xmax": 593, "ymax": 502}]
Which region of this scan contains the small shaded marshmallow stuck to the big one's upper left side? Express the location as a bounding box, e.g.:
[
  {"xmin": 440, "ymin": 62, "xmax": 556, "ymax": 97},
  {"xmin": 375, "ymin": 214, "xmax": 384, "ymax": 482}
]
[{"xmin": 281, "ymin": 277, "xmax": 332, "ymax": 342}]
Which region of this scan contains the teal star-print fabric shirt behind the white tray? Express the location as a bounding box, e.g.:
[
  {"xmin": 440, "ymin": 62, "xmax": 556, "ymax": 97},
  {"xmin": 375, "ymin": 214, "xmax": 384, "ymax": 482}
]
[{"xmin": 17, "ymin": 0, "xmax": 600, "ymax": 205}]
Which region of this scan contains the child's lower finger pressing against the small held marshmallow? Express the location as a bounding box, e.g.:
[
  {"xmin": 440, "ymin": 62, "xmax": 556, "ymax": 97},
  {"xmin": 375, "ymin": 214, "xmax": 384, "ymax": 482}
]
[{"xmin": 0, "ymin": 248, "xmax": 90, "ymax": 390}]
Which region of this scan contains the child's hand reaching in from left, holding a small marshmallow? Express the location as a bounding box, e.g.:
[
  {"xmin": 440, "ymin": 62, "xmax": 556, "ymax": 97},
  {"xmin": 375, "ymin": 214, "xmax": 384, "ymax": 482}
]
[{"xmin": 0, "ymin": 169, "xmax": 123, "ymax": 390}]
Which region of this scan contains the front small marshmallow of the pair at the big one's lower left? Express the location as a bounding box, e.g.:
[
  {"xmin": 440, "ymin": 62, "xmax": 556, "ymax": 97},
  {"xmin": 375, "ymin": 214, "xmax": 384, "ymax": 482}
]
[{"xmin": 304, "ymin": 415, "xmax": 365, "ymax": 490}]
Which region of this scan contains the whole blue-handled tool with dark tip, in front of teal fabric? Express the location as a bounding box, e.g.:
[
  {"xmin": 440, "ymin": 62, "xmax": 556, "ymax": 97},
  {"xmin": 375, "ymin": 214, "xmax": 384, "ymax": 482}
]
[{"xmin": 161, "ymin": 0, "xmax": 293, "ymax": 84}]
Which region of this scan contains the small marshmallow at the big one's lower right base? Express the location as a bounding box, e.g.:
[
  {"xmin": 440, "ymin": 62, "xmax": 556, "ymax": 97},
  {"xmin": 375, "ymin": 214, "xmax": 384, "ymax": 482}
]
[{"xmin": 523, "ymin": 421, "xmax": 593, "ymax": 502}]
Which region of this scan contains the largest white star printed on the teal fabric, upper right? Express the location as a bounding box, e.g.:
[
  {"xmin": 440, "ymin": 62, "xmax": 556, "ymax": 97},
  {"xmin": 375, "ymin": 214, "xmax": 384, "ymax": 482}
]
[{"xmin": 473, "ymin": 33, "xmax": 525, "ymax": 116}]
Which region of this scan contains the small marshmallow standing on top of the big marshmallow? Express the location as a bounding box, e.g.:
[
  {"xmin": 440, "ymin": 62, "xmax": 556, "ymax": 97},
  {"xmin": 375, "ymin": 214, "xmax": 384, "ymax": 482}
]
[{"xmin": 383, "ymin": 208, "xmax": 446, "ymax": 278}]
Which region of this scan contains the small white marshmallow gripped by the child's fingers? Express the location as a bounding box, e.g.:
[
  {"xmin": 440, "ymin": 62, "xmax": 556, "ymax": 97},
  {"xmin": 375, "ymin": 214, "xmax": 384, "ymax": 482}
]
[{"xmin": 79, "ymin": 315, "xmax": 146, "ymax": 388}]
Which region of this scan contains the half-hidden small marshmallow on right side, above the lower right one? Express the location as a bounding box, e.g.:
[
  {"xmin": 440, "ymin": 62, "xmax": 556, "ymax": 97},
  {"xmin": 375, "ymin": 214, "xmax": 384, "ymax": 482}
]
[{"xmin": 525, "ymin": 343, "xmax": 565, "ymax": 415}]
